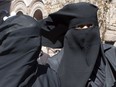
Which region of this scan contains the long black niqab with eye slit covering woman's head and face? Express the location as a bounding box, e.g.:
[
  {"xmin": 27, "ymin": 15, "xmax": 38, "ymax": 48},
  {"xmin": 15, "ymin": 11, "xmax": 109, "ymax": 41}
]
[{"xmin": 56, "ymin": 2, "xmax": 102, "ymax": 87}]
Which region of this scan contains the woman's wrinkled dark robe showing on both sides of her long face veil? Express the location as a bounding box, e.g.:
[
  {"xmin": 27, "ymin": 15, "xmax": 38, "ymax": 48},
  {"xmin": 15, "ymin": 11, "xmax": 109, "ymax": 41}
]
[{"xmin": 37, "ymin": 44, "xmax": 116, "ymax": 87}]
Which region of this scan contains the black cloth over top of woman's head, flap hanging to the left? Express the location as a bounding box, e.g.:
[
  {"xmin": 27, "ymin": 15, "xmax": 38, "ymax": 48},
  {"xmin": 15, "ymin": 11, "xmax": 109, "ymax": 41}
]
[{"xmin": 40, "ymin": 2, "xmax": 98, "ymax": 48}]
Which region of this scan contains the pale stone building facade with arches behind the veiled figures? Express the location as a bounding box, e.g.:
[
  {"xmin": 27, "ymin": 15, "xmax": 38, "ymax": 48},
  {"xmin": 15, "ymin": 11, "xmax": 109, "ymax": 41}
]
[{"xmin": 0, "ymin": 0, "xmax": 116, "ymax": 44}]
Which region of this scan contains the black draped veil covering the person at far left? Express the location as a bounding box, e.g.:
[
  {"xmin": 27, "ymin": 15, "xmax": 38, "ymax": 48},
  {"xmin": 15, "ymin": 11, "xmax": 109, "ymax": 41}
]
[{"xmin": 0, "ymin": 15, "xmax": 41, "ymax": 87}]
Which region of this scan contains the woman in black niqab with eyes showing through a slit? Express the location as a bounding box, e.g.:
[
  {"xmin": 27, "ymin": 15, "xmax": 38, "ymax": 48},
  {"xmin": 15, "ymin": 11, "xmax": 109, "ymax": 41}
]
[{"xmin": 39, "ymin": 2, "xmax": 116, "ymax": 87}]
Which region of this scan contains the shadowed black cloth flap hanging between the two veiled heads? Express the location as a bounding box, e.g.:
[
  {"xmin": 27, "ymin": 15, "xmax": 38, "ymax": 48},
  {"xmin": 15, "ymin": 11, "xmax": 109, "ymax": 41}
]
[{"xmin": 38, "ymin": 12, "xmax": 68, "ymax": 48}]
